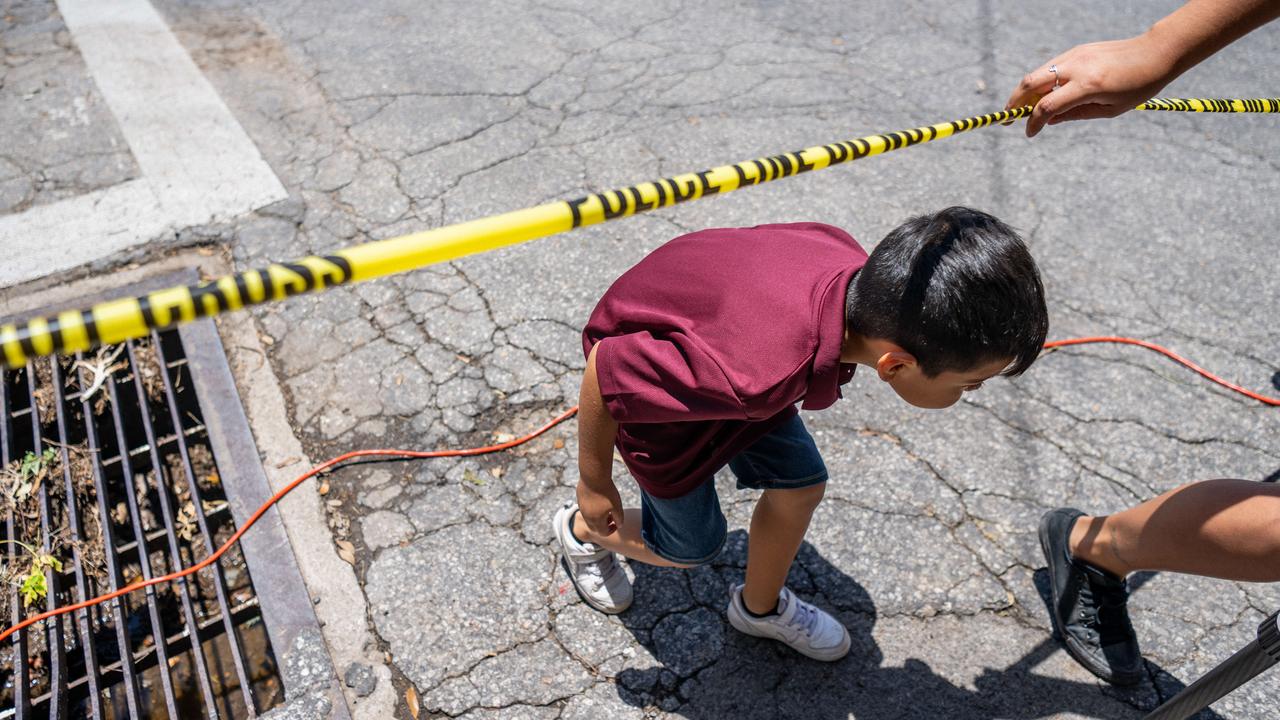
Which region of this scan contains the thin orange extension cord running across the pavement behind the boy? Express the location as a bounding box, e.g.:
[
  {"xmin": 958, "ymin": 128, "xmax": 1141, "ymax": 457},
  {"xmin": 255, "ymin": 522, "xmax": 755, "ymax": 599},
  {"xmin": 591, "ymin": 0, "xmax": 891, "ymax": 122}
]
[{"xmin": 0, "ymin": 337, "xmax": 1280, "ymax": 643}]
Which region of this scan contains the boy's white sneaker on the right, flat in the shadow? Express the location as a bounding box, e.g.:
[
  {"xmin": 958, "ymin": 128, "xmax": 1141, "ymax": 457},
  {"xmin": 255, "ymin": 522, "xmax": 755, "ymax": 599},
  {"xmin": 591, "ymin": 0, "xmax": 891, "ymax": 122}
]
[{"xmin": 728, "ymin": 585, "xmax": 851, "ymax": 662}]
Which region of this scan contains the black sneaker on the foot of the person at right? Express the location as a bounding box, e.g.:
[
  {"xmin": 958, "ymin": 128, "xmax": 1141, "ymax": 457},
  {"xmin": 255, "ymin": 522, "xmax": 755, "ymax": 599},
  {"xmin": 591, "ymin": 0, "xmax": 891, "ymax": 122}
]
[{"xmin": 1039, "ymin": 507, "xmax": 1146, "ymax": 685}]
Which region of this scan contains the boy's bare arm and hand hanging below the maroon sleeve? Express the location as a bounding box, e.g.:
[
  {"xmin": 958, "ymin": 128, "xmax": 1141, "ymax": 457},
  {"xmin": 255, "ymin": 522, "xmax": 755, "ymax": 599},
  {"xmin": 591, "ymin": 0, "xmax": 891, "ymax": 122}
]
[{"xmin": 577, "ymin": 345, "xmax": 622, "ymax": 536}]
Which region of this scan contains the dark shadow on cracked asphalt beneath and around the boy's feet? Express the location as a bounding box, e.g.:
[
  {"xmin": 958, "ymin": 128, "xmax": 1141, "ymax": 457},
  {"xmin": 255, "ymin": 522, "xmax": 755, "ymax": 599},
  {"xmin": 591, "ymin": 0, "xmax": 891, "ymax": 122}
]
[{"xmin": 617, "ymin": 530, "xmax": 1217, "ymax": 720}]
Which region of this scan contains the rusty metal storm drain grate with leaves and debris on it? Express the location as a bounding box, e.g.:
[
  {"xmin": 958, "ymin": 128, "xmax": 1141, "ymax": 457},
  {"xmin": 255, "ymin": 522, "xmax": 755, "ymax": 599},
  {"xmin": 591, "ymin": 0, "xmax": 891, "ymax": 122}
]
[{"xmin": 0, "ymin": 320, "xmax": 290, "ymax": 719}]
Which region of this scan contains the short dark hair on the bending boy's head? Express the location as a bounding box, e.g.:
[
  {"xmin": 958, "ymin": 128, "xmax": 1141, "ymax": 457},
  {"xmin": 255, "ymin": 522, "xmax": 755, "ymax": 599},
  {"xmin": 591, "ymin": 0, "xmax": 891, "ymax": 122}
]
[{"xmin": 845, "ymin": 206, "xmax": 1048, "ymax": 377}]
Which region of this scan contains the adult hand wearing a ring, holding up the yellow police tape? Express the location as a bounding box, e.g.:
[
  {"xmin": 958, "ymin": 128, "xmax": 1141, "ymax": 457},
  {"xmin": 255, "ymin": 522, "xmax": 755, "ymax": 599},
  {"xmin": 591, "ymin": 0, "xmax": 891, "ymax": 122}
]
[{"xmin": 1005, "ymin": 33, "xmax": 1176, "ymax": 137}]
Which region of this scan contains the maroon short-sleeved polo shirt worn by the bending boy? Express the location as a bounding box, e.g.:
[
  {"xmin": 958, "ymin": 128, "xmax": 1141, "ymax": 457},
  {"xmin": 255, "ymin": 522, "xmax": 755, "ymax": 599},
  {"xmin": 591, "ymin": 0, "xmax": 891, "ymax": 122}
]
[{"xmin": 582, "ymin": 223, "xmax": 867, "ymax": 498}]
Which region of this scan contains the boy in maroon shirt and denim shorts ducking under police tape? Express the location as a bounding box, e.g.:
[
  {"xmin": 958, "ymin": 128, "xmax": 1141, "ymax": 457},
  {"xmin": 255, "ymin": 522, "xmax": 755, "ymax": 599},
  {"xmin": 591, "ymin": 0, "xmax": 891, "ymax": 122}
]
[{"xmin": 554, "ymin": 208, "xmax": 1048, "ymax": 661}]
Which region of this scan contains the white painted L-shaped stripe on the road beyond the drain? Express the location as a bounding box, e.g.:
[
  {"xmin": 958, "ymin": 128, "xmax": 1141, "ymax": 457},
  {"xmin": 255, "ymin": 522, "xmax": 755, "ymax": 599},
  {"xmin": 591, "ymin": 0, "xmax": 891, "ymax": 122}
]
[{"xmin": 0, "ymin": 0, "xmax": 288, "ymax": 286}]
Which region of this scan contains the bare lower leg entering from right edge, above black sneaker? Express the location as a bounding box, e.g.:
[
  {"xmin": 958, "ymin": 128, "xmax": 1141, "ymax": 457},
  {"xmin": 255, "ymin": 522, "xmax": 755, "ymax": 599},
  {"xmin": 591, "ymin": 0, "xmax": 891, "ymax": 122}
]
[{"xmin": 1070, "ymin": 479, "xmax": 1280, "ymax": 582}]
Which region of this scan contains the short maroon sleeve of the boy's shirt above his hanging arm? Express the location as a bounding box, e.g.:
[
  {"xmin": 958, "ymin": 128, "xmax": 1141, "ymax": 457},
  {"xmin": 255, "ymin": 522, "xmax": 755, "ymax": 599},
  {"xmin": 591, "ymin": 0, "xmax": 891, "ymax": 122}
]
[{"xmin": 595, "ymin": 332, "xmax": 748, "ymax": 423}]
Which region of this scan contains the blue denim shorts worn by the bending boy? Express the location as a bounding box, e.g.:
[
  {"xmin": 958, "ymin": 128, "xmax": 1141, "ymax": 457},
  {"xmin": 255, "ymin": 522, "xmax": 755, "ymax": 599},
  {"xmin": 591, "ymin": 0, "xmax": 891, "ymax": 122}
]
[{"xmin": 640, "ymin": 415, "xmax": 827, "ymax": 565}]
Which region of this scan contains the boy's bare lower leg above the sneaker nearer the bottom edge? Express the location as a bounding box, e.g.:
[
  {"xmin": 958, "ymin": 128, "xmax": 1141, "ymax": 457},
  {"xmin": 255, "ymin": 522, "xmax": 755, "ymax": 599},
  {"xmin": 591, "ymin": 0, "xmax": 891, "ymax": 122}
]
[{"xmin": 742, "ymin": 483, "xmax": 827, "ymax": 614}]
